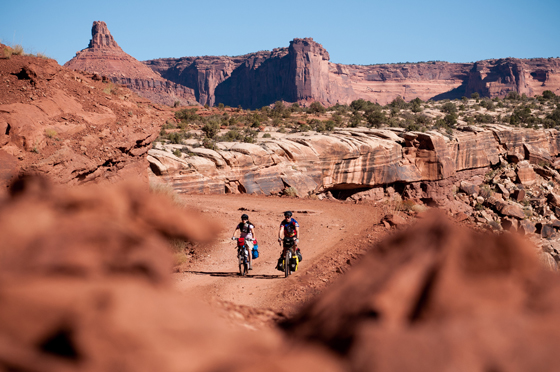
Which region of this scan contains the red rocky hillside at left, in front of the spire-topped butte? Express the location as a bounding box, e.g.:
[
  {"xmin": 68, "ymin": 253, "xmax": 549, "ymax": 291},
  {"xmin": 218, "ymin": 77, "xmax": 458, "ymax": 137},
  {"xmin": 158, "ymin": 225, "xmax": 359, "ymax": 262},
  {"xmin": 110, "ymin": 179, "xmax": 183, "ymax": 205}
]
[{"xmin": 0, "ymin": 45, "xmax": 172, "ymax": 188}]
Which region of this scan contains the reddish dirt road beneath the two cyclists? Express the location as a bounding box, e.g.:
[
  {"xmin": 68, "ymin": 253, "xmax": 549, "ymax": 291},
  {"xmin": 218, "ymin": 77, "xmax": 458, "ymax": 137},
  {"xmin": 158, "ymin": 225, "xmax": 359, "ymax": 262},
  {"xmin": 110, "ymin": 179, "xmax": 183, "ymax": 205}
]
[{"xmin": 175, "ymin": 195, "xmax": 380, "ymax": 312}]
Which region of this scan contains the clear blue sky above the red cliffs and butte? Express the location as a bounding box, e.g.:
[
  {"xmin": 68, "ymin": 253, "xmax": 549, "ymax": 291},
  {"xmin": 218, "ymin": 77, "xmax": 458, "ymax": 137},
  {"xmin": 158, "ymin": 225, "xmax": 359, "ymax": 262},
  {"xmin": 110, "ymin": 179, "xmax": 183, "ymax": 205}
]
[{"xmin": 0, "ymin": 0, "xmax": 560, "ymax": 65}]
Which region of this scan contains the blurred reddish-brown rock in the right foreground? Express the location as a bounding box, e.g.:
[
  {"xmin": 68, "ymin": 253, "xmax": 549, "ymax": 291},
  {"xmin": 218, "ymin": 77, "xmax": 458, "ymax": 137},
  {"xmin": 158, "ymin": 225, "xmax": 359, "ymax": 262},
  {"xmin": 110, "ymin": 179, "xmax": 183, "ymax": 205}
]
[{"xmin": 284, "ymin": 212, "xmax": 560, "ymax": 371}]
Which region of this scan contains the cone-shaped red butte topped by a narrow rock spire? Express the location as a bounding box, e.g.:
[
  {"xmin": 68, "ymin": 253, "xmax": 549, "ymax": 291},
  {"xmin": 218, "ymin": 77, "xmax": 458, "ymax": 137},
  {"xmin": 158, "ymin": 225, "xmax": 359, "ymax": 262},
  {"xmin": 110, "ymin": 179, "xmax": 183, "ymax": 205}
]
[{"xmin": 64, "ymin": 21, "xmax": 196, "ymax": 105}]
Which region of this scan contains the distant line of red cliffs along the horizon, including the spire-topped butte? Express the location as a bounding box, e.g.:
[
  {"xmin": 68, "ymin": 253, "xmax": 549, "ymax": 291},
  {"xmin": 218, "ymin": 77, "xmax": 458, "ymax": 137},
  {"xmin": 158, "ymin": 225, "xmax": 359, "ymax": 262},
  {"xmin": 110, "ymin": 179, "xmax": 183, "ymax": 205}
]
[{"xmin": 65, "ymin": 22, "xmax": 560, "ymax": 109}]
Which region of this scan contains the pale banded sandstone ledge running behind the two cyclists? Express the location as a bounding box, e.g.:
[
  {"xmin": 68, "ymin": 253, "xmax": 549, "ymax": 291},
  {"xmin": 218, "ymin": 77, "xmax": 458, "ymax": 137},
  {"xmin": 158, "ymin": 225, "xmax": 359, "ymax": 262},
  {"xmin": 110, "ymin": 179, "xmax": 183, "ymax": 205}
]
[{"xmin": 148, "ymin": 125, "xmax": 560, "ymax": 199}]
